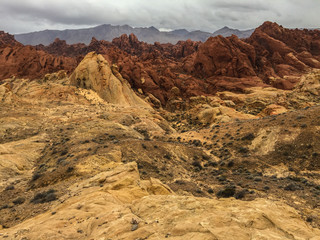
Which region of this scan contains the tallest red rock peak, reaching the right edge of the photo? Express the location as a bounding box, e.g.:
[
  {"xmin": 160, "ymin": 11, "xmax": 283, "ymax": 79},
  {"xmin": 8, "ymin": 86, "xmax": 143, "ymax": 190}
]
[{"xmin": 247, "ymin": 22, "xmax": 320, "ymax": 89}]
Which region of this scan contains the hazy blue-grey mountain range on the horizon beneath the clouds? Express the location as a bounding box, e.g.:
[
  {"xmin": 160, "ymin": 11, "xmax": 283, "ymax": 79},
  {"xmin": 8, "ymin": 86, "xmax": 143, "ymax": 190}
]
[{"xmin": 15, "ymin": 24, "xmax": 253, "ymax": 45}]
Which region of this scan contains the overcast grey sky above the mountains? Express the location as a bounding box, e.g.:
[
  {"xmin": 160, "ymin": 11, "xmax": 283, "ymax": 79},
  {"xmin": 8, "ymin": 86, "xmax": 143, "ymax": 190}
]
[{"xmin": 0, "ymin": 0, "xmax": 320, "ymax": 33}]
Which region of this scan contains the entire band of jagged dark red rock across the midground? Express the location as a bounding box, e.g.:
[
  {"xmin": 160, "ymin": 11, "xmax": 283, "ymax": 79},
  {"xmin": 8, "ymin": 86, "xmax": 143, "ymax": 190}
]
[{"xmin": 0, "ymin": 22, "xmax": 320, "ymax": 105}]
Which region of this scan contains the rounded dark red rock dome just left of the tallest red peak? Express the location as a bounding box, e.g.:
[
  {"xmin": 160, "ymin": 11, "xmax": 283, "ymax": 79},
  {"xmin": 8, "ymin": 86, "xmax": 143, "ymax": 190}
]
[{"xmin": 185, "ymin": 35, "xmax": 266, "ymax": 94}]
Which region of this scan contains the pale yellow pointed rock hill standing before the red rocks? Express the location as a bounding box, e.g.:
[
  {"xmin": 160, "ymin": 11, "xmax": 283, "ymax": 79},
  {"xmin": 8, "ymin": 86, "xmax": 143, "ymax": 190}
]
[{"xmin": 70, "ymin": 52, "xmax": 149, "ymax": 107}]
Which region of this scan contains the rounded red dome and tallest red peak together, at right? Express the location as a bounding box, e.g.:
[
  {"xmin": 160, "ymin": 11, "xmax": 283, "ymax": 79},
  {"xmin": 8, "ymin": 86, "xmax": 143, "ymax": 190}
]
[{"xmin": 188, "ymin": 22, "xmax": 320, "ymax": 90}]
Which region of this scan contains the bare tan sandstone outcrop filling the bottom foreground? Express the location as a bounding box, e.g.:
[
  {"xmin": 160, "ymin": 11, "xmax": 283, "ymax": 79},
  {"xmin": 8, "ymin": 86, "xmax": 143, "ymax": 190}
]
[{"xmin": 0, "ymin": 162, "xmax": 320, "ymax": 240}]
